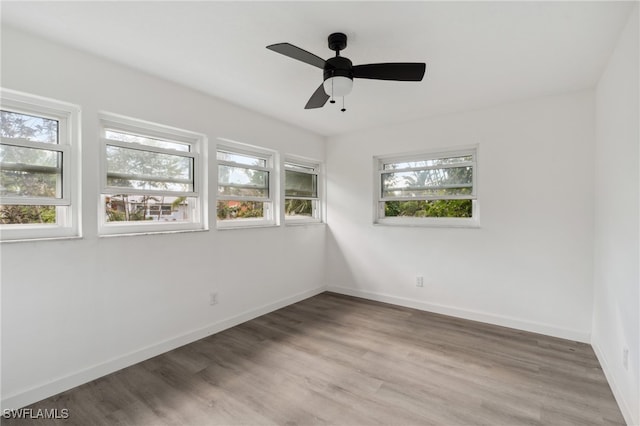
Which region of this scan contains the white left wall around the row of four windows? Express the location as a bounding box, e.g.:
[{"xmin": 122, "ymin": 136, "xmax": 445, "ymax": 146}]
[{"xmin": 1, "ymin": 27, "xmax": 326, "ymax": 408}]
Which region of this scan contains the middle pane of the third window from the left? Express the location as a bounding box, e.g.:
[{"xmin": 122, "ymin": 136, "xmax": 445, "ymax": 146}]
[{"xmin": 218, "ymin": 165, "xmax": 269, "ymax": 197}]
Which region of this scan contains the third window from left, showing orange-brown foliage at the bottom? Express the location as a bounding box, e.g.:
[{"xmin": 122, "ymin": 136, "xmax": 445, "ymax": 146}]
[{"xmin": 216, "ymin": 141, "xmax": 276, "ymax": 228}]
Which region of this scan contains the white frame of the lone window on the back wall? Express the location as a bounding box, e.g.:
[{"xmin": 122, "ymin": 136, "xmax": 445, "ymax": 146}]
[{"xmin": 373, "ymin": 145, "xmax": 480, "ymax": 228}]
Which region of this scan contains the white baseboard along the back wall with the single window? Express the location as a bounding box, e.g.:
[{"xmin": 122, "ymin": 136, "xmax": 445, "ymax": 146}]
[{"xmin": 327, "ymin": 286, "xmax": 591, "ymax": 343}]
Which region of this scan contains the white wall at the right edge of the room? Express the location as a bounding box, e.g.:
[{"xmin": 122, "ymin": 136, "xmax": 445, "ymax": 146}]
[{"xmin": 592, "ymin": 6, "xmax": 640, "ymax": 425}]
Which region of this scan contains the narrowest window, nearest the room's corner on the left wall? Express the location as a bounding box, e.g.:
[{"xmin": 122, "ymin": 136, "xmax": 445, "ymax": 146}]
[{"xmin": 284, "ymin": 158, "xmax": 322, "ymax": 224}]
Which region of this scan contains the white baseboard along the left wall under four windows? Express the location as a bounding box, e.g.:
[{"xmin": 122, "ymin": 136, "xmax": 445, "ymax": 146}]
[{"xmin": 1, "ymin": 287, "xmax": 326, "ymax": 410}]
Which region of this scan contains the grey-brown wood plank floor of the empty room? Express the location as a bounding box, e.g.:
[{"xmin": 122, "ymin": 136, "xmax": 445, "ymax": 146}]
[{"xmin": 3, "ymin": 293, "xmax": 624, "ymax": 426}]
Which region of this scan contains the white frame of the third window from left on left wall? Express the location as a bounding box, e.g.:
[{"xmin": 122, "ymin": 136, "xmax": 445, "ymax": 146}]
[{"xmin": 215, "ymin": 138, "xmax": 280, "ymax": 230}]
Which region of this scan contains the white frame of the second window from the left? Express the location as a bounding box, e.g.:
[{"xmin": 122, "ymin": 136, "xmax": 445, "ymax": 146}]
[{"xmin": 98, "ymin": 112, "xmax": 208, "ymax": 236}]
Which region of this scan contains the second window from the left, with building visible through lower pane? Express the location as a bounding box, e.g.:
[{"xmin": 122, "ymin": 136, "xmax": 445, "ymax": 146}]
[{"xmin": 98, "ymin": 114, "xmax": 206, "ymax": 234}]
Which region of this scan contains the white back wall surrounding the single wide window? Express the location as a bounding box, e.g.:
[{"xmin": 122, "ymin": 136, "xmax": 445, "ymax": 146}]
[{"xmin": 327, "ymin": 91, "xmax": 595, "ymax": 341}]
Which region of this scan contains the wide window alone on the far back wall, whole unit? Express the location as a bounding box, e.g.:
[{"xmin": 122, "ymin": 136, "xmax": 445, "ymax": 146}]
[{"xmin": 375, "ymin": 148, "xmax": 478, "ymax": 226}]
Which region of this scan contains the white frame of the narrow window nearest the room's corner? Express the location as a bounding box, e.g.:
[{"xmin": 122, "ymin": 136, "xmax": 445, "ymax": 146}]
[{"xmin": 281, "ymin": 155, "xmax": 325, "ymax": 225}]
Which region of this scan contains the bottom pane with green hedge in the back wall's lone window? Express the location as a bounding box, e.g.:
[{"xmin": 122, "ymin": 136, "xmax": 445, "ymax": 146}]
[{"xmin": 384, "ymin": 200, "xmax": 473, "ymax": 217}]
